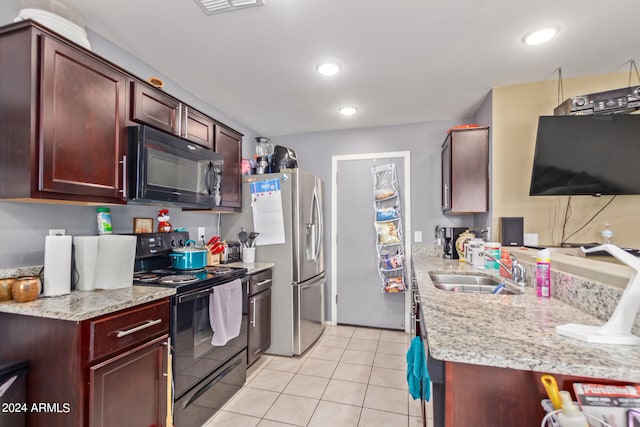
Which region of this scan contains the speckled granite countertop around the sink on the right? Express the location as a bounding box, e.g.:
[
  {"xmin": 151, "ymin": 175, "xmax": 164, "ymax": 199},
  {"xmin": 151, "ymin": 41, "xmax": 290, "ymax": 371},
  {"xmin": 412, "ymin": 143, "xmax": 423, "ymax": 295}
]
[{"xmin": 413, "ymin": 253, "xmax": 640, "ymax": 383}]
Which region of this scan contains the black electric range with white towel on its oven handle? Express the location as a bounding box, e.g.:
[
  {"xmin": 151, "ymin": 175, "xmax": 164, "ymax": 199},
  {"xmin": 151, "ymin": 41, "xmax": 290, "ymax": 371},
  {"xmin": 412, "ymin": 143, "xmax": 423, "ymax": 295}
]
[{"xmin": 133, "ymin": 232, "xmax": 248, "ymax": 426}]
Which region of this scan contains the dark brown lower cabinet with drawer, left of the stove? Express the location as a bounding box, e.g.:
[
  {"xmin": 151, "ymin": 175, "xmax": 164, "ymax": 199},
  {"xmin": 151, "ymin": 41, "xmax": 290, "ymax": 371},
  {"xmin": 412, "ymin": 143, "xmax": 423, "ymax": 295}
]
[{"xmin": 0, "ymin": 298, "xmax": 170, "ymax": 427}]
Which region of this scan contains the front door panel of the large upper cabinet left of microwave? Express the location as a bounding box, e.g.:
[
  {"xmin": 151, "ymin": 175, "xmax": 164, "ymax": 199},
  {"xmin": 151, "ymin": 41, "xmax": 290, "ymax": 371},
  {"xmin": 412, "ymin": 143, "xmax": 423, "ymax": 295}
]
[{"xmin": 39, "ymin": 36, "xmax": 126, "ymax": 199}]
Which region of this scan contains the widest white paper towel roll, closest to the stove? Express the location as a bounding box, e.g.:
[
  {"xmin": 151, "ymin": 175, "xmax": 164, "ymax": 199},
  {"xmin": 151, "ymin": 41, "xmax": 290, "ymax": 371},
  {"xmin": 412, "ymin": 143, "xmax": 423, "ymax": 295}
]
[{"xmin": 94, "ymin": 235, "xmax": 137, "ymax": 289}]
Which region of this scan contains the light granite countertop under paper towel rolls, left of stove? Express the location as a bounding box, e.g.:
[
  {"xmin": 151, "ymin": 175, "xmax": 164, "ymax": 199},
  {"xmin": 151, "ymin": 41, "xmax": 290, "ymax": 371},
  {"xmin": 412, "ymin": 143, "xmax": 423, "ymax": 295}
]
[{"xmin": 0, "ymin": 285, "xmax": 175, "ymax": 322}]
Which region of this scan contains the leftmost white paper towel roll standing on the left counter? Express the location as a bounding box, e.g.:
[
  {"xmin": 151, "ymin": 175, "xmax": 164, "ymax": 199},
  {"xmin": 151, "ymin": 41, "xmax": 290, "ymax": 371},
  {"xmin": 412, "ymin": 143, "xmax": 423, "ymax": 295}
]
[{"xmin": 43, "ymin": 236, "xmax": 71, "ymax": 297}]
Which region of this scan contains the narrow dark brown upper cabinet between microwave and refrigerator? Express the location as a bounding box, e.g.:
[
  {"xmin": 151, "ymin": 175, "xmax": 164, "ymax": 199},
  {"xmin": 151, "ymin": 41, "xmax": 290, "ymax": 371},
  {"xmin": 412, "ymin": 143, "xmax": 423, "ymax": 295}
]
[{"xmin": 215, "ymin": 125, "xmax": 242, "ymax": 211}]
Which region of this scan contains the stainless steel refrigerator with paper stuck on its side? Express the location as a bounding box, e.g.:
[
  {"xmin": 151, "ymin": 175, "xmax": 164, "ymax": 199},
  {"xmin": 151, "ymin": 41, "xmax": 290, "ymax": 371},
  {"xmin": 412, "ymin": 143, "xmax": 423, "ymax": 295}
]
[{"xmin": 221, "ymin": 169, "xmax": 326, "ymax": 356}]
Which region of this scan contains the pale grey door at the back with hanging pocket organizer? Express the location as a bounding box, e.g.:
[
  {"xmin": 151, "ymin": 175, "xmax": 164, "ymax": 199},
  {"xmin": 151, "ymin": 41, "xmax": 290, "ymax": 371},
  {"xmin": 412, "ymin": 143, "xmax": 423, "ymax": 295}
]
[{"xmin": 332, "ymin": 153, "xmax": 410, "ymax": 330}]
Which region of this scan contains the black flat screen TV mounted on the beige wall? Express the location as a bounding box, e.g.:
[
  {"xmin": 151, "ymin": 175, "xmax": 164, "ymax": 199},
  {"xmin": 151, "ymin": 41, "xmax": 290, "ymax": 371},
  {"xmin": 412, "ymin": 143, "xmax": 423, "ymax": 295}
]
[{"xmin": 529, "ymin": 114, "xmax": 640, "ymax": 196}]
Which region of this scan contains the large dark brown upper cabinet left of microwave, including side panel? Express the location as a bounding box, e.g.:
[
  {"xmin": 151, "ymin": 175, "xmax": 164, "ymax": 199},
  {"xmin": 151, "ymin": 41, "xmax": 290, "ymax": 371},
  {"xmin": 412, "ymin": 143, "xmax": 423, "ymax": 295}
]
[{"xmin": 0, "ymin": 22, "xmax": 127, "ymax": 203}]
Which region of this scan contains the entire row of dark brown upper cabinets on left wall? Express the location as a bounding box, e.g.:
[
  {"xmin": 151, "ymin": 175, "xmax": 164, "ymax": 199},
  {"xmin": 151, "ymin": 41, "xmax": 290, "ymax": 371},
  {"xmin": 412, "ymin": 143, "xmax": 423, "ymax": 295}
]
[{"xmin": 0, "ymin": 21, "xmax": 242, "ymax": 207}]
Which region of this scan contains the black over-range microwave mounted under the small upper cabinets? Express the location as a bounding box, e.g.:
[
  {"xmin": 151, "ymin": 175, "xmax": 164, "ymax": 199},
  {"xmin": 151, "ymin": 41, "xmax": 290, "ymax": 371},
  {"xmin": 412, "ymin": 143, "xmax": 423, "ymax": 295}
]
[{"xmin": 128, "ymin": 126, "xmax": 223, "ymax": 208}]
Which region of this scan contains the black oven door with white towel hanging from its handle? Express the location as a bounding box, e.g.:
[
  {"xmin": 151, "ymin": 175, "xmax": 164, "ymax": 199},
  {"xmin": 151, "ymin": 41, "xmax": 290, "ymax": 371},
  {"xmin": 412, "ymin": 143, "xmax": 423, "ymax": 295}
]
[{"xmin": 171, "ymin": 279, "xmax": 247, "ymax": 398}]
